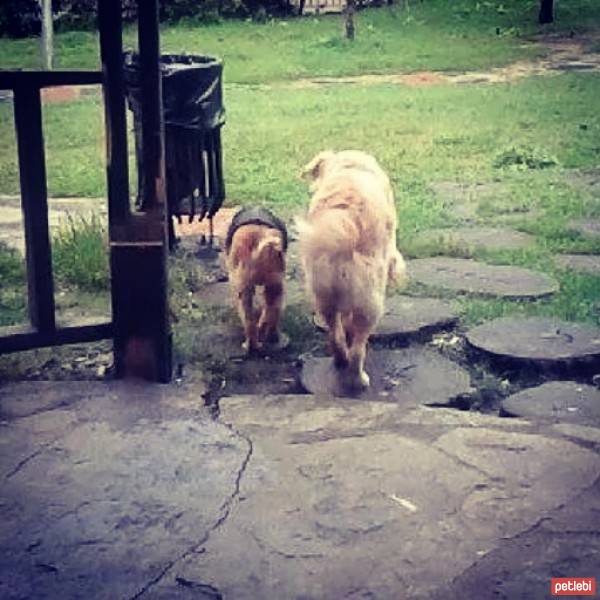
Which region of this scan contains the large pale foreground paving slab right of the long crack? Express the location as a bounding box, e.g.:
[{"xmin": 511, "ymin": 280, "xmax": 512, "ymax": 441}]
[{"xmin": 146, "ymin": 396, "xmax": 600, "ymax": 600}]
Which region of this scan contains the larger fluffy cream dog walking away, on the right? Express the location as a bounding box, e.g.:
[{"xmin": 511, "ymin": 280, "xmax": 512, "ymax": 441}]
[{"xmin": 297, "ymin": 150, "xmax": 406, "ymax": 390}]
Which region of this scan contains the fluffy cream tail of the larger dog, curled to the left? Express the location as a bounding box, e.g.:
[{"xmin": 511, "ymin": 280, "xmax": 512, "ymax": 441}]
[{"xmin": 296, "ymin": 209, "xmax": 360, "ymax": 258}]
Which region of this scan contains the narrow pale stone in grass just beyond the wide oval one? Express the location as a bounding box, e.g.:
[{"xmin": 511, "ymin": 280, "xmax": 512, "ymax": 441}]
[{"xmin": 417, "ymin": 227, "xmax": 535, "ymax": 251}]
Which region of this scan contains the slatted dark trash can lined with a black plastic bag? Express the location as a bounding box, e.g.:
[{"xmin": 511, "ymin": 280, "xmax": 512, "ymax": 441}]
[{"xmin": 124, "ymin": 52, "xmax": 225, "ymax": 247}]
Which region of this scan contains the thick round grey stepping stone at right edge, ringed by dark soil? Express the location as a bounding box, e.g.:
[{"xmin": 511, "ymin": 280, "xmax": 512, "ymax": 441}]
[{"xmin": 466, "ymin": 317, "xmax": 600, "ymax": 364}]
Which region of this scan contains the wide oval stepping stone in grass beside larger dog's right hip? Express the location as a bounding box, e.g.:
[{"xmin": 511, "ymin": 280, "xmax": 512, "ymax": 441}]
[{"xmin": 408, "ymin": 256, "xmax": 559, "ymax": 298}]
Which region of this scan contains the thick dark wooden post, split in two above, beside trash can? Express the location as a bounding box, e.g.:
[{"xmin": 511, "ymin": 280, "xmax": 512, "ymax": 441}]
[{"xmin": 99, "ymin": 0, "xmax": 171, "ymax": 383}]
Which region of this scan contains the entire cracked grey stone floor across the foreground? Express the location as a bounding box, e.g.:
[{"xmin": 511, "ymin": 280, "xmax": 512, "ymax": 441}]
[{"xmin": 0, "ymin": 382, "xmax": 600, "ymax": 600}]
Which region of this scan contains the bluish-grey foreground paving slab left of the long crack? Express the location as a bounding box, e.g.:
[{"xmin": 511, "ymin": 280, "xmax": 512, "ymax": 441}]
[{"xmin": 0, "ymin": 382, "xmax": 249, "ymax": 600}]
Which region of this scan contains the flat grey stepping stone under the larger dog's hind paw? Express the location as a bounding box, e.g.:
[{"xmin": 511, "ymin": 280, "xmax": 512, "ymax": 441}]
[{"xmin": 300, "ymin": 347, "xmax": 472, "ymax": 405}]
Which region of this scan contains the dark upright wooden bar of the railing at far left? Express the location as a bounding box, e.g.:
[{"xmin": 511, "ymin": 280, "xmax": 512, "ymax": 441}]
[{"xmin": 14, "ymin": 85, "xmax": 55, "ymax": 334}]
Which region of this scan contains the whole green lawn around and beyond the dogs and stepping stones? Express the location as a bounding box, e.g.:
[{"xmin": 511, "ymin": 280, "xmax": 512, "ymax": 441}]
[{"xmin": 0, "ymin": 0, "xmax": 600, "ymax": 356}]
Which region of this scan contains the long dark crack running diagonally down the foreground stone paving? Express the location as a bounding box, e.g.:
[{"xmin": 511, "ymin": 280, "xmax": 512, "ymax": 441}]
[{"xmin": 129, "ymin": 423, "xmax": 254, "ymax": 600}]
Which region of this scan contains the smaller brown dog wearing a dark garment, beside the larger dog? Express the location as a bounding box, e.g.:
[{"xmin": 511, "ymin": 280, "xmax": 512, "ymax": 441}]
[{"xmin": 225, "ymin": 208, "xmax": 287, "ymax": 353}]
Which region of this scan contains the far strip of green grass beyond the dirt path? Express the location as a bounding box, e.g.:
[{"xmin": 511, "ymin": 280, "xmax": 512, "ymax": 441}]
[{"xmin": 0, "ymin": 0, "xmax": 600, "ymax": 83}]
